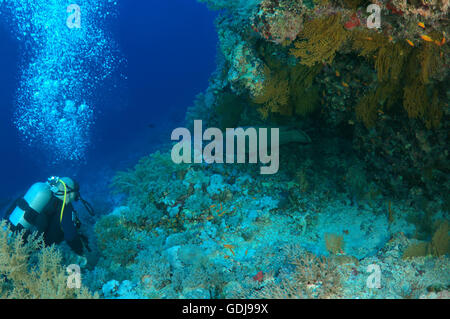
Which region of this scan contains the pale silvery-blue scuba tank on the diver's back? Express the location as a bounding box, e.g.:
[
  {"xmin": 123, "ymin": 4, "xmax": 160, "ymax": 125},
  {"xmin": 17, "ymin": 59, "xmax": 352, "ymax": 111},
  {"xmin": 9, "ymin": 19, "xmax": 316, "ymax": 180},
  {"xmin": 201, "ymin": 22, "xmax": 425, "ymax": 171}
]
[{"xmin": 9, "ymin": 183, "xmax": 53, "ymax": 231}]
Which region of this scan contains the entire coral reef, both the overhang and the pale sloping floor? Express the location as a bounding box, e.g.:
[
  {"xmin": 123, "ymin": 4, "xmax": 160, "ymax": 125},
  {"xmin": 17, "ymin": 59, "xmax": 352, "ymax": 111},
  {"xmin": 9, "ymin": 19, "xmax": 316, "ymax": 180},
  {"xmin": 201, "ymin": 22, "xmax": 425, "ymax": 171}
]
[{"xmin": 81, "ymin": 0, "xmax": 450, "ymax": 299}]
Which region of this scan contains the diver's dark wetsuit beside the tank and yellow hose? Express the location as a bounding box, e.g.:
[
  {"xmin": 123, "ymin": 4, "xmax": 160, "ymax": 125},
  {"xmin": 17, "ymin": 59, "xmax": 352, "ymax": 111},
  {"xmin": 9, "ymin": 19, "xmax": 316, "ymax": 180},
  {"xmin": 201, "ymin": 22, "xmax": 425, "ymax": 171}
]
[{"xmin": 5, "ymin": 195, "xmax": 83, "ymax": 255}]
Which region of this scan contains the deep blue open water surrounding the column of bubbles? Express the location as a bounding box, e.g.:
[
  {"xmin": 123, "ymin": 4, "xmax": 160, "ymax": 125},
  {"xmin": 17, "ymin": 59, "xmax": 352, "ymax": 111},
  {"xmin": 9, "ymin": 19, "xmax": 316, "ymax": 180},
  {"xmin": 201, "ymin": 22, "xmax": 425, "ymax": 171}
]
[{"xmin": 0, "ymin": 0, "xmax": 217, "ymax": 198}]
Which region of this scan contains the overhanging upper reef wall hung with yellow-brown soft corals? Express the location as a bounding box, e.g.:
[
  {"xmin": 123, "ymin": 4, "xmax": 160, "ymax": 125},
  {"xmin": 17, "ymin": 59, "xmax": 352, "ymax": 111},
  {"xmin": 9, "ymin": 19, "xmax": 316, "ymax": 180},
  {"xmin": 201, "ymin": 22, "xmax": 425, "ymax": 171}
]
[{"xmin": 187, "ymin": 0, "xmax": 450, "ymax": 206}]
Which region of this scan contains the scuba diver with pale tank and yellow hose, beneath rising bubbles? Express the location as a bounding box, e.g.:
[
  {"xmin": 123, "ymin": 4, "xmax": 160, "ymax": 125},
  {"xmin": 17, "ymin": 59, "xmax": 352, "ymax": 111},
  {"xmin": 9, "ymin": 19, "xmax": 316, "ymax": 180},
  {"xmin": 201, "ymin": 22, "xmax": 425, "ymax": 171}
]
[{"xmin": 4, "ymin": 176, "xmax": 93, "ymax": 257}]
